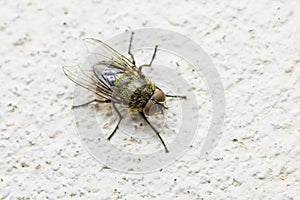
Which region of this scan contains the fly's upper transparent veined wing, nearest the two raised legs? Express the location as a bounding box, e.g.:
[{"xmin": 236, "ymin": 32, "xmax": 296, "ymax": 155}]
[{"xmin": 84, "ymin": 38, "xmax": 138, "ymax": 74}]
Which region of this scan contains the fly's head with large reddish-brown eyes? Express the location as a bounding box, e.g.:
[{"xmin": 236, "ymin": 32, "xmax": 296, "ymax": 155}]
[{"xmin": 143, "ymin": 90, "xmax": 168, "ymax": 115}]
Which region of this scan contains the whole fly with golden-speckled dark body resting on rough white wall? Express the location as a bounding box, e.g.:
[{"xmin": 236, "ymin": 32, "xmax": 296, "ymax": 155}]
[{"xmin": 63, "ymin": 32, "xmax": 186, "ymax": 152}]
